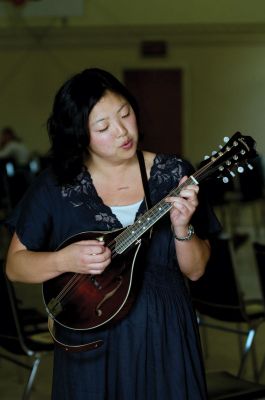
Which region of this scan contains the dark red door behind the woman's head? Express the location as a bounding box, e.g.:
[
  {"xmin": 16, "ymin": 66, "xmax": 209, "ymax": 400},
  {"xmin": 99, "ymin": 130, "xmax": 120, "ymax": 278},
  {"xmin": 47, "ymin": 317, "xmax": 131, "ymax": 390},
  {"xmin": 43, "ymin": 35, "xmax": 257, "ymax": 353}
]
[{"xmin": 124, "ymin": 69, "xmax": 182, "ymax": 155}]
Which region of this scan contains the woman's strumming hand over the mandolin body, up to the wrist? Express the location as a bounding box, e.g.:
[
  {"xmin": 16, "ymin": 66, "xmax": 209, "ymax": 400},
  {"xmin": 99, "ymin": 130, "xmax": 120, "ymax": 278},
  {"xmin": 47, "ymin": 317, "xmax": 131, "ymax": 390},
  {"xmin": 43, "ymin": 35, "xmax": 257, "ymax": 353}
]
[{"xmin": 58, "ymin": 240, "xmax": 111, "ymax": 275}]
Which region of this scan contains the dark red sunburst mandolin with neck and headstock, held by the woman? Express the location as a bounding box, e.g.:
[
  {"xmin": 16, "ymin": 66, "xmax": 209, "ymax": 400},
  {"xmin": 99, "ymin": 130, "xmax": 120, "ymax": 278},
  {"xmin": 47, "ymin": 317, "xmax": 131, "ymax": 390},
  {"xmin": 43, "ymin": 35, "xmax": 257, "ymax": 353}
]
[{"xmin": 42, "ymin": 132, "xmax": 257, "ymax": 330}]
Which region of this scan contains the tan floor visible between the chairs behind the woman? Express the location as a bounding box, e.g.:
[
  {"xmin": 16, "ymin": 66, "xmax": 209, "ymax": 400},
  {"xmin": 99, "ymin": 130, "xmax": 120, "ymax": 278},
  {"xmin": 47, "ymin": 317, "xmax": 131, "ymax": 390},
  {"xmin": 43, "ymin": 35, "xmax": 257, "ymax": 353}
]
[{"xmin": 0, "ymin": 198, "xmax": 265, "ymax": 400}]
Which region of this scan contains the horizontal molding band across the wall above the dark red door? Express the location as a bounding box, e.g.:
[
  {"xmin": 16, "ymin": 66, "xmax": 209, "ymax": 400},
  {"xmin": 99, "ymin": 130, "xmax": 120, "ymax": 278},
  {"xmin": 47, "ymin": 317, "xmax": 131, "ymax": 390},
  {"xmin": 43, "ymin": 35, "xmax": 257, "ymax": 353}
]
[{"xmin": 0, "ymin": 22, "xmax": 265, "ymax": 50}]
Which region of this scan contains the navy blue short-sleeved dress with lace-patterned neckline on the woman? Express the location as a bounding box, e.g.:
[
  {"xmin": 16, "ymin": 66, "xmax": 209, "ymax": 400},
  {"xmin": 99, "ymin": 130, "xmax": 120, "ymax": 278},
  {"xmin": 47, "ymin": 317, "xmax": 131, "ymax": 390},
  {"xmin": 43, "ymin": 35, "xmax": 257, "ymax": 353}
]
[{"xmin": 9, "ymin": 154, "xmax": 220, "ymax": 400}]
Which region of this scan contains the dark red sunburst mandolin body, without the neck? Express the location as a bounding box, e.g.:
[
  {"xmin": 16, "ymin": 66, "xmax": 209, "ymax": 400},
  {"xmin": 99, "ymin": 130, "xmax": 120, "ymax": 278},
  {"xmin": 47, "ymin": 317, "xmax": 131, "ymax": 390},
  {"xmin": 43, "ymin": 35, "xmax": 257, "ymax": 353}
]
[{"xmin": 42, "ymin": 231, "xmax": 142, "ymax": 330}]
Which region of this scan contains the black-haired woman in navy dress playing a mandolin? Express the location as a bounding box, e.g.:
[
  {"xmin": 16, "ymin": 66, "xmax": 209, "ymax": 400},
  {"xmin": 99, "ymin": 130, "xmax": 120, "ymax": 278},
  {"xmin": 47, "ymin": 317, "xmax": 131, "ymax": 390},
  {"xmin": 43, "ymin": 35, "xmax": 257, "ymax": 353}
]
[{"xmin": 7, "ymin": 68, "xmax": 219, "ymax": 400}]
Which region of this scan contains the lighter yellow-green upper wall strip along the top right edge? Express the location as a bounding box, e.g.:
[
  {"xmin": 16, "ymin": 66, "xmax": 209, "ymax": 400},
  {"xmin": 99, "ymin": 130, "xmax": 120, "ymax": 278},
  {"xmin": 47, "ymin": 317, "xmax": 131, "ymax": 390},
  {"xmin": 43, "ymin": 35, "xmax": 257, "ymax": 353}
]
[{"xmin": 82, "ymin": 0, "xmax": 265, "ymax": 26}]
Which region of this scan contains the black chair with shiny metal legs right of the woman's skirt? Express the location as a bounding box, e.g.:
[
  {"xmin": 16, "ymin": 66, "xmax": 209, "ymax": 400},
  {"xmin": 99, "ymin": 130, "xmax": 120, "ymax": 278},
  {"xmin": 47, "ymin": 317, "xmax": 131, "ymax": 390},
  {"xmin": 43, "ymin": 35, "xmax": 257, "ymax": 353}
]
[{"xmin": 189, "ymin": 237, "xmax": 265, "ymax": 379}]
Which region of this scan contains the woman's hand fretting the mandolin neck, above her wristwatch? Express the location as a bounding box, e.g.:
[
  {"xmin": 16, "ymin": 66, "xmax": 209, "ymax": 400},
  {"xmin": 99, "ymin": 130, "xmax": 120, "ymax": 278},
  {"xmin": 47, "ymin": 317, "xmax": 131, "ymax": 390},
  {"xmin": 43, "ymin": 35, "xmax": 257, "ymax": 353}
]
[{"xmin": 166, "ymin": 176, "xmax": 199, "ymax": 236}]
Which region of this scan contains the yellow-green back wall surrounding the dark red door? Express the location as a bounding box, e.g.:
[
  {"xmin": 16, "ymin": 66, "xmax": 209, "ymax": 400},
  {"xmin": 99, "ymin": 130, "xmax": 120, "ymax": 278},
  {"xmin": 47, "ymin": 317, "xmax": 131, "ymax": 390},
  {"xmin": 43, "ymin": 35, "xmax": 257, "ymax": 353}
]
[{"xmin": 0, "ymin": 0, "xmax": 265, "ymax": 162}]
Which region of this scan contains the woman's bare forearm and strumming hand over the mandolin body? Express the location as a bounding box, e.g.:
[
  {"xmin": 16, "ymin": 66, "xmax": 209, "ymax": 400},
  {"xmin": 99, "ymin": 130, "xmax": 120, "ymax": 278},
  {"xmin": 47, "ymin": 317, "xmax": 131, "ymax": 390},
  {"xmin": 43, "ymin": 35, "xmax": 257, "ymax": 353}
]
[{"xmin": 6, "ymin": 233, "xmax": 111, "ymax": 283}]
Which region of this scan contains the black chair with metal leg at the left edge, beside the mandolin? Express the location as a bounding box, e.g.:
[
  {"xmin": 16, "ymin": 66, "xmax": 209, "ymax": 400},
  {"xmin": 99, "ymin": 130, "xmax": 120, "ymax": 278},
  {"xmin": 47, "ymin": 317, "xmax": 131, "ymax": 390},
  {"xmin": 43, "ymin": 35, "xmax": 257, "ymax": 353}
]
[{"xmin": 0, "ymin": 261, "xmax": 54, "ymax": 400}]
